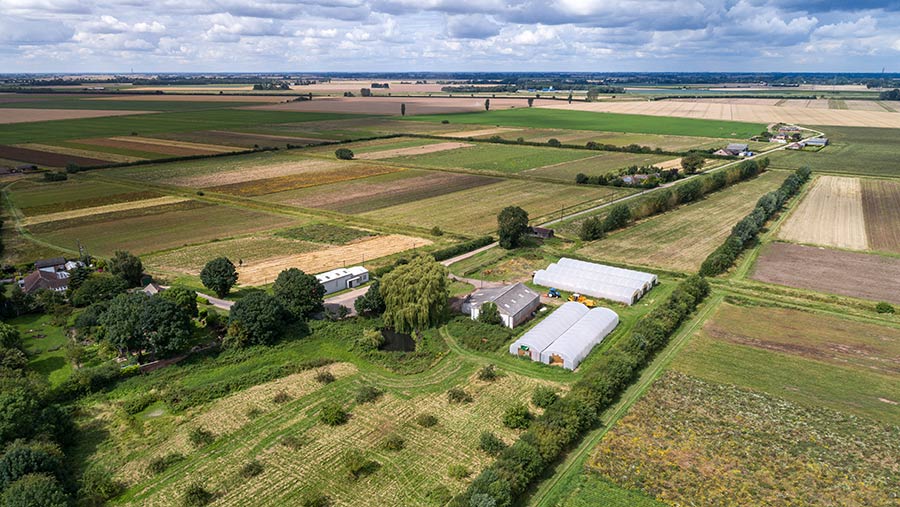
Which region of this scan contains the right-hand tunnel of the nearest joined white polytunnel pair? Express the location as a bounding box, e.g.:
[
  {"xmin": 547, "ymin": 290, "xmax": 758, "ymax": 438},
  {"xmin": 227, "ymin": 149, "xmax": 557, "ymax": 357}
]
[{"xmin": 541, "ymin": 308, "xmax": 619, "ymax": 370}]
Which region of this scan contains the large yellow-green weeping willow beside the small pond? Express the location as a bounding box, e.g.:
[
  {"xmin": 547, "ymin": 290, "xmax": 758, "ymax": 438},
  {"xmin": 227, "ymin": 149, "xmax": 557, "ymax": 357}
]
[{"xmin": 380, "ymin": 255, "xmax": 450, "ymax": 333}]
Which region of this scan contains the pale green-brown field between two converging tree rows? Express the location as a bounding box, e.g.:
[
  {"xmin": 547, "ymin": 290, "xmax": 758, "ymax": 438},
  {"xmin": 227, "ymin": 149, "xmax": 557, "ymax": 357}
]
[{"xmin": 578, "ymin": 171, "xmax": 785, "ymax": 272}]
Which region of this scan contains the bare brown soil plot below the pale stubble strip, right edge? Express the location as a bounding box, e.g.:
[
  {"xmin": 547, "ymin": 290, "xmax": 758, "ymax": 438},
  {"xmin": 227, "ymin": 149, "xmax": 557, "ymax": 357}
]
[{"xmin": 752, "ymin": 243, "xmax": 900, "ymax": 304}]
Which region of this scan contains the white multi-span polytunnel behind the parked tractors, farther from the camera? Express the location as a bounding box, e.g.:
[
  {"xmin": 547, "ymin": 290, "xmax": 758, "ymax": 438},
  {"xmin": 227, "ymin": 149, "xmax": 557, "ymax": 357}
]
[{"xmin": 534, "ymin": 258, "xmax": 657, "ymax": 305}]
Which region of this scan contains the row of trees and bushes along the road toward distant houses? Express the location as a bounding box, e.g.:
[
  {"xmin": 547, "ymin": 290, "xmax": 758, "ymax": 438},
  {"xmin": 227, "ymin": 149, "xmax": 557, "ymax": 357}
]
[{"xmin": 578, "ymin": 158, "xmax": 769, "ymax": 241}]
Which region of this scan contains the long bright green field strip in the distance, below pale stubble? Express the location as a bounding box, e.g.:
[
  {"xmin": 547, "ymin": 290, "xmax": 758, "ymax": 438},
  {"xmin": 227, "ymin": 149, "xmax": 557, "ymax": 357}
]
[{"xmin": 406, "ymin": 108, "xmax": 766, "ymax": 139}]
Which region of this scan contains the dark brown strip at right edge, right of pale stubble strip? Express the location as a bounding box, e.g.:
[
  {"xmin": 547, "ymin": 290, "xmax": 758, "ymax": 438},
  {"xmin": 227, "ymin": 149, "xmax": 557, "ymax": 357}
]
[{"xmin": 862, "ymin": 179, "xmax": 900, "ymax": 253}]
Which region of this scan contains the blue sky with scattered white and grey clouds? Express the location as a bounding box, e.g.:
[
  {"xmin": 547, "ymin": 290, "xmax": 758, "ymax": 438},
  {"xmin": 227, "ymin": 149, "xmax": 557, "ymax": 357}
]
[{"xmin": 0, "ymin": 0, "xmax": 900, "ymax": 73}]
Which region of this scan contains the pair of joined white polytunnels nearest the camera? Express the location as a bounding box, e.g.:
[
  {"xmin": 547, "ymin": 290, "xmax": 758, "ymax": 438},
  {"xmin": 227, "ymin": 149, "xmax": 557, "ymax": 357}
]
[{"xmin": 509, "ymin": 302, "xmax": 619, "ymax": 370}]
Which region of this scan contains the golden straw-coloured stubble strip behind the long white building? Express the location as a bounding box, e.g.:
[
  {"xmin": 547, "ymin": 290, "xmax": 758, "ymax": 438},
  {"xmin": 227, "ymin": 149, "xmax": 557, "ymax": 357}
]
[{"xmin": 232, "ymin": 234, "xmax": 431, "ymax": 286}]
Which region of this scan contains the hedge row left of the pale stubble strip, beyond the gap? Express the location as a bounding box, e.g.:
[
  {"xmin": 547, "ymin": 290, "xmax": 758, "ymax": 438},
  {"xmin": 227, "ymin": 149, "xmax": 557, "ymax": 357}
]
[{"xmin": 700, "ymin": 167, "xmax": 810, "ymax": 276}]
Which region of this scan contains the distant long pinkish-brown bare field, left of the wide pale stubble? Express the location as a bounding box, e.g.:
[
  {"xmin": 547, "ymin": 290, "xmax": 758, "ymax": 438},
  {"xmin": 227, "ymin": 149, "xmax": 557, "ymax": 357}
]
[{"xmin": 243, "ymin": 97, "xmax": 528, "ymax": 116}]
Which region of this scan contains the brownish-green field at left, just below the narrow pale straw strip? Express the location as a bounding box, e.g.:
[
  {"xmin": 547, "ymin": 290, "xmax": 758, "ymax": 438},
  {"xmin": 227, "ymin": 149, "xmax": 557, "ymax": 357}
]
[{"xmin": 29, "ymin": 201, "xmax": 296, "ymax": 256}]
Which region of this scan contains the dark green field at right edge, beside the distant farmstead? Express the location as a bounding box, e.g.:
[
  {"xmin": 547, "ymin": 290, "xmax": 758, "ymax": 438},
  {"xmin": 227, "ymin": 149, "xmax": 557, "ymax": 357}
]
[{"xmin": 770, "ymin": 126, "xmax": 900, "ymax": 177}]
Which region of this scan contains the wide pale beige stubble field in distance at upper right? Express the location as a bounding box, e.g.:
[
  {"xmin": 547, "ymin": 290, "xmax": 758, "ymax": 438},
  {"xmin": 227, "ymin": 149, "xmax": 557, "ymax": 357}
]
[{"xmin": 541, "ymin": 99, "xmax": 900, "ymax": 128}]
